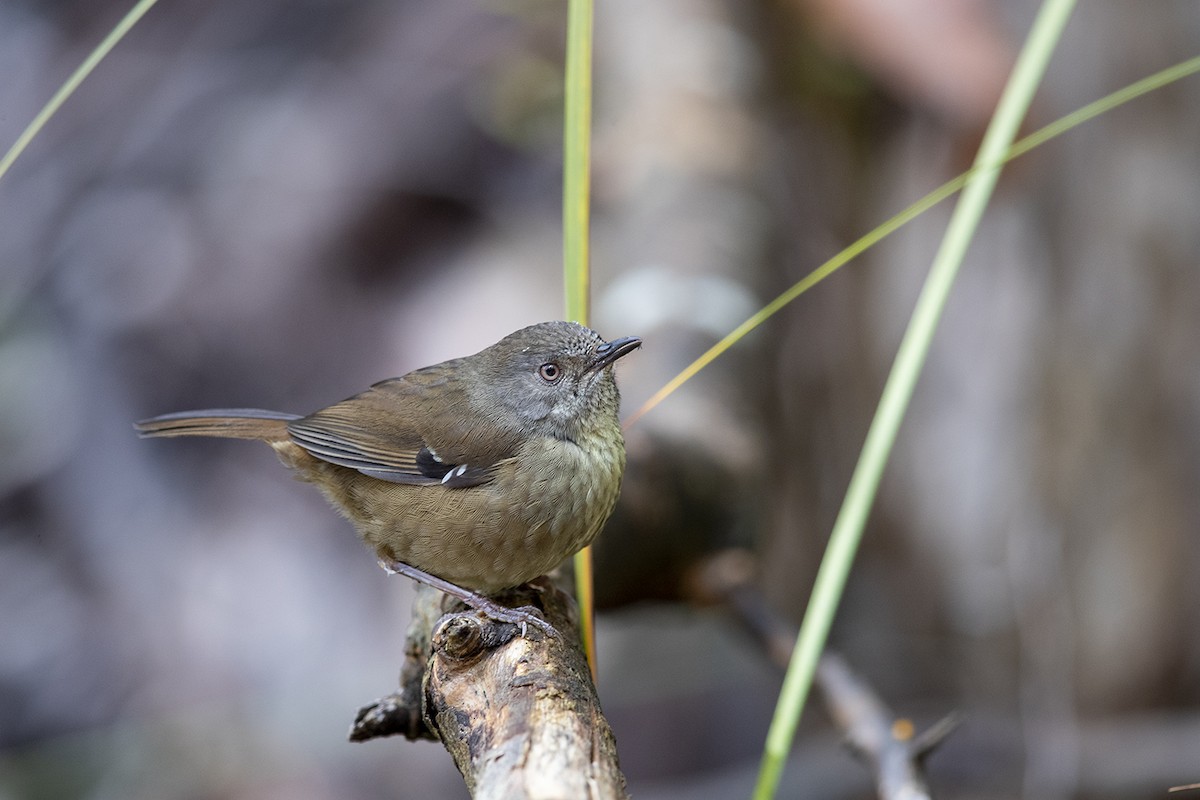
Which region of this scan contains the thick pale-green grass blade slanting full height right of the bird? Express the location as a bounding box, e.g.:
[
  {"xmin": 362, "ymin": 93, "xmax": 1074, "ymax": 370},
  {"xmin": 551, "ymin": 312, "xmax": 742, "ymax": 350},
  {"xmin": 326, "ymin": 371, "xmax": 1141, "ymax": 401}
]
[{"xmin": 754, "ymin": 0, "xmax": 1075, "ymax": 800}]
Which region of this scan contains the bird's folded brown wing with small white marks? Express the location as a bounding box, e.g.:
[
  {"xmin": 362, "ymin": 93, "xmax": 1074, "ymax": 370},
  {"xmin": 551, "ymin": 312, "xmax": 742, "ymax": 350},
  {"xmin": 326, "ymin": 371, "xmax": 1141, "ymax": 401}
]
[{"xmin": 288, "ymin": 365, "xmax": 518, "ymax": 488}]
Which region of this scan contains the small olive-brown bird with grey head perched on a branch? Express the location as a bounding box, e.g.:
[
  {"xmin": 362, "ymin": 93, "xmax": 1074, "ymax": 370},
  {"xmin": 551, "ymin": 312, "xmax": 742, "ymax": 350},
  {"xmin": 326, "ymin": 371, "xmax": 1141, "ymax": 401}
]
[{"xmin": 136, "ymin": 321, "xmax": 642, "ymax": 633}]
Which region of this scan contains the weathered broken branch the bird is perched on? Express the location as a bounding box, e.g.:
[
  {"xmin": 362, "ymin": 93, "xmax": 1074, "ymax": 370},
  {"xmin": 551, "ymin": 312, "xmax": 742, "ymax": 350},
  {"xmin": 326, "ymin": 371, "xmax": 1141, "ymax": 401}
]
[{"xmin": 350, "ymin": 581, "xmax": 628, "ymax": 800}]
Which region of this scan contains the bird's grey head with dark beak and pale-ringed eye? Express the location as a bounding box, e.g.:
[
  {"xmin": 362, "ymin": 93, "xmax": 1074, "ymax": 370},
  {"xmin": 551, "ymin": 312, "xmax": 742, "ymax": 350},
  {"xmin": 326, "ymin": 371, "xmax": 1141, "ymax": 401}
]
[{"xmin": 468, "ymin": 321, "xmax": 642, "ymax": 439}]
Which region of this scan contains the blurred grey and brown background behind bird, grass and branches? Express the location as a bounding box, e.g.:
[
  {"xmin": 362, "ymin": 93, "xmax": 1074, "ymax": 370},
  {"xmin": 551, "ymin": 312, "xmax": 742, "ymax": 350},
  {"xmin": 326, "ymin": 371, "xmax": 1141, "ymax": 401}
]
[{"xmin": 0, "ymin": 0, "xmax": 1200, "ymax": 800}]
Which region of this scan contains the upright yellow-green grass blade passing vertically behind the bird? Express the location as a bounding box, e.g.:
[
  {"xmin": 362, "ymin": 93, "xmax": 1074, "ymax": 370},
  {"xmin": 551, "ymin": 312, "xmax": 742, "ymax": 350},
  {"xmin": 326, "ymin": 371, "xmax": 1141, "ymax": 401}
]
[{"xmin": 563, "ymin": 0, "xmax": 596, "ymax": 676}]
